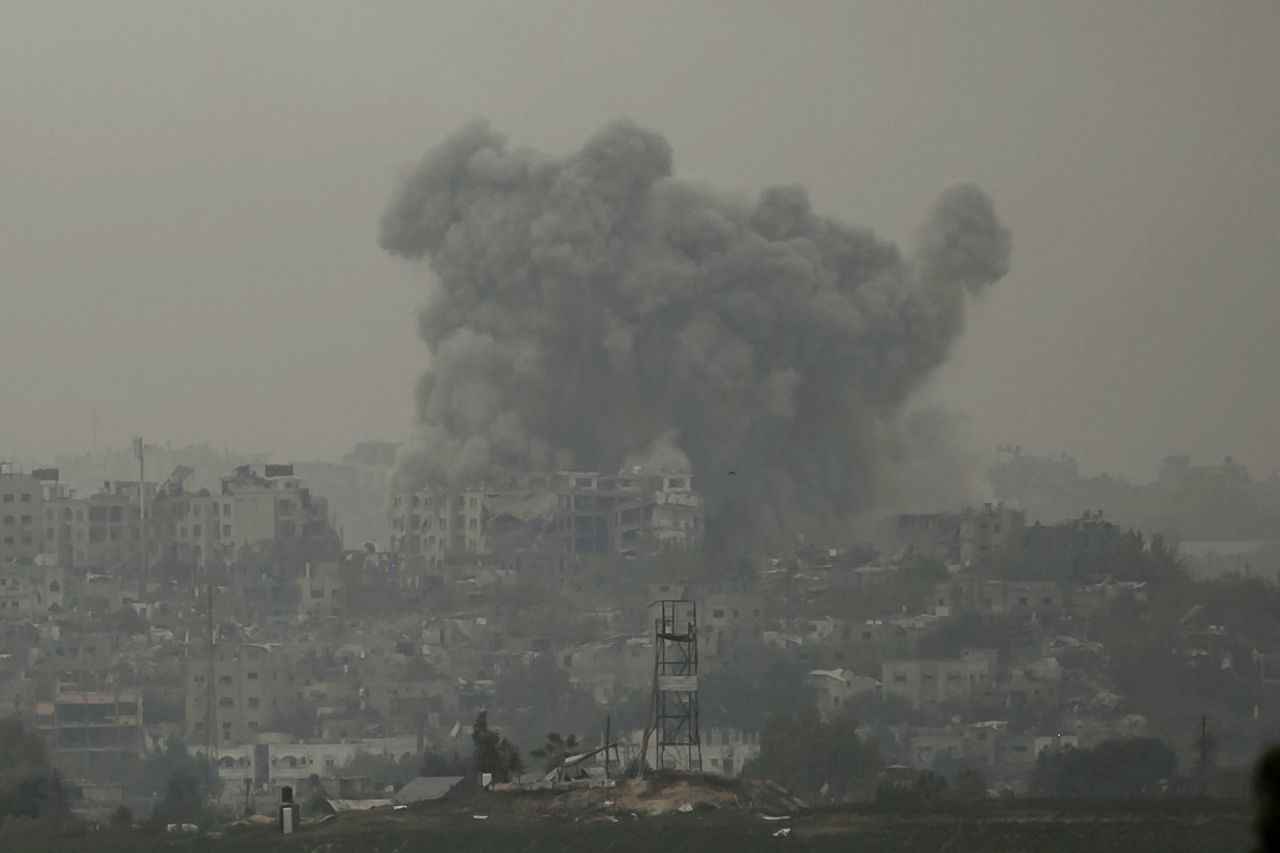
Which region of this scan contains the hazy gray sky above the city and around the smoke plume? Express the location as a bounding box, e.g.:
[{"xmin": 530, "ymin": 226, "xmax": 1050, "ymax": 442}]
[{"xmin": 0, "ymin": 0, "xmax": 1280, "ymax": 479}]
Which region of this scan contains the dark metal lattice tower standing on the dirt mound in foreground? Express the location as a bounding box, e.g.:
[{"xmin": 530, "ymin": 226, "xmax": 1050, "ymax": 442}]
[{"xmin": 652, "ymin": 599, "xmax": 703, "ymax": 772}]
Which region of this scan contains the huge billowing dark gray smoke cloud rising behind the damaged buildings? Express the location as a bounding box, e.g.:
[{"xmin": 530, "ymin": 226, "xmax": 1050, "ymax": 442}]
[{"xmin": 380, "ymin": 122, "xmax": 1010, "ymax": 540}]
